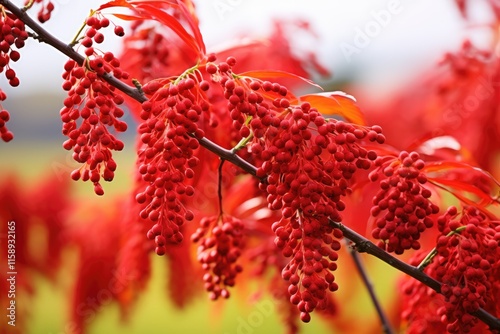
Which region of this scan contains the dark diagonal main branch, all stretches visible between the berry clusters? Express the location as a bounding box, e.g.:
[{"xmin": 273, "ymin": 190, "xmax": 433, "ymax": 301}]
[{"xmin": 0, "ymin": 0, "xmax": 500, "ymax": 330}]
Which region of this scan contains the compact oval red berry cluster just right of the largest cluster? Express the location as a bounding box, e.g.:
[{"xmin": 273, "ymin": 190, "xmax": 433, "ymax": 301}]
[{"xmin": 370, "ymin": 151, "xmax": 439, "ymax": 254}]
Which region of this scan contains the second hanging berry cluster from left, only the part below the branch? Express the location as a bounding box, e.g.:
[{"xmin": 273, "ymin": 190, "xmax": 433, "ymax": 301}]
[{"xmin": 60, "ymin": 60, "xmax": 127, "ymax": 195}]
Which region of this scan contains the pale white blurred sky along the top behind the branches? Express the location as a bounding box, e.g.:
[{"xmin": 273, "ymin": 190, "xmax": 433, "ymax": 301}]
[{"xmin": 0, "ymin": 0, "xmax": 492, "ymax": 96}]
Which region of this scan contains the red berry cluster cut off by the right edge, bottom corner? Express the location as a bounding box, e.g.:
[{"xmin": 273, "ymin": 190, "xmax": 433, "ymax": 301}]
[{"xmin": 430, "ymin": 207, "xmax": 500, "ymax": 333}]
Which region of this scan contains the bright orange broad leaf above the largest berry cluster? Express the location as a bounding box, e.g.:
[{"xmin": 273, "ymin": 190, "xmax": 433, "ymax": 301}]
[{"xmin": 299, "ymin": 92, "xmax": 366, "ymax": 125}]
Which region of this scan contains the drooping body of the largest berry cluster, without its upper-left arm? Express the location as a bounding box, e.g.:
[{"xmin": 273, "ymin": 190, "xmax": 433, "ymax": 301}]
[{"xmin": 260, "ymin": 115, "xmax": 383, "ymax": 322}]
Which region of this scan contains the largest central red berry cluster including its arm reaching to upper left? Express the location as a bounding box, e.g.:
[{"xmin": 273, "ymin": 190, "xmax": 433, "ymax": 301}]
[{"xmin": 197, "ymin": 57, "xmax": 385, "ymax": 322}]
